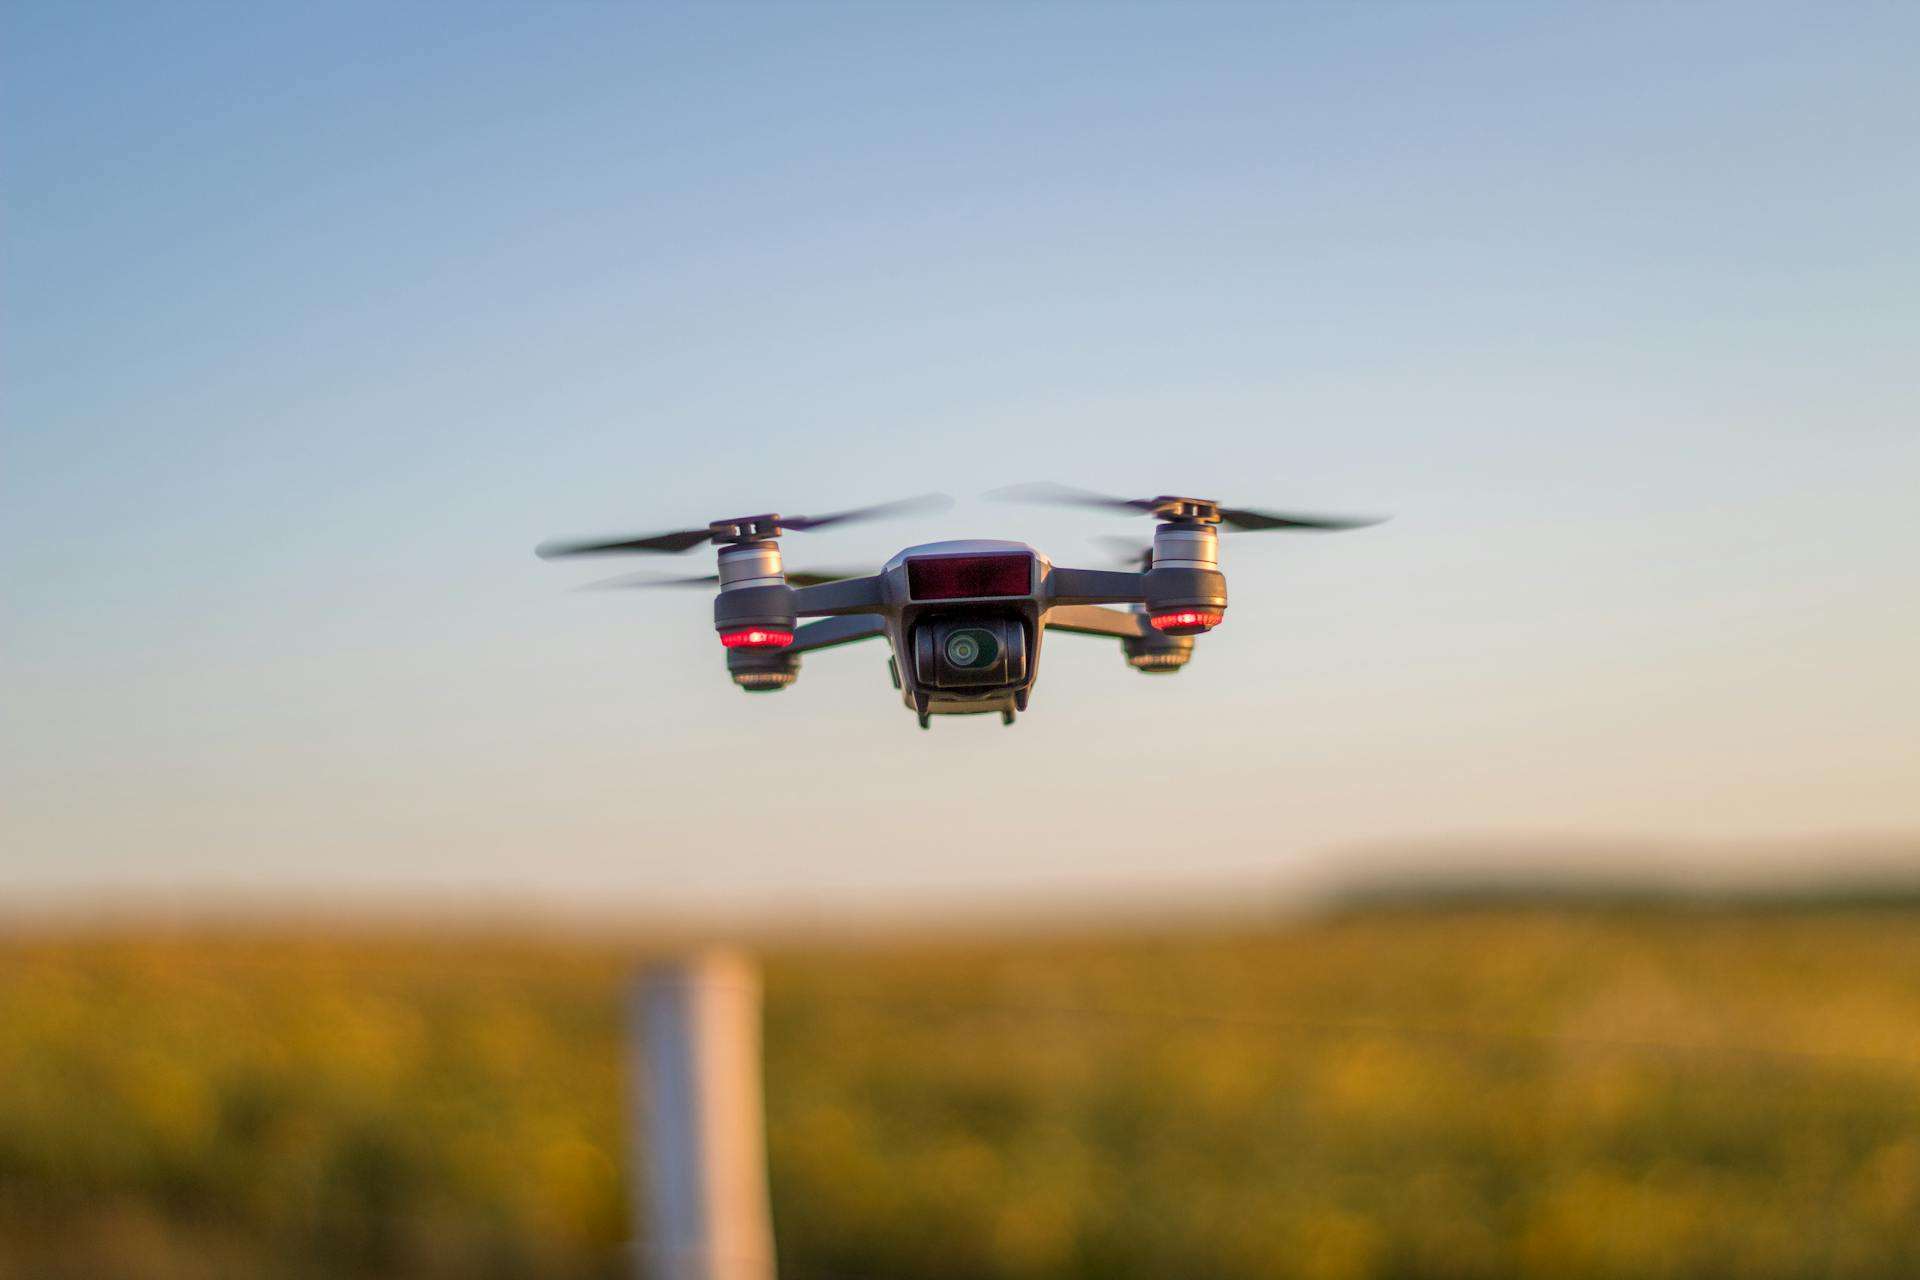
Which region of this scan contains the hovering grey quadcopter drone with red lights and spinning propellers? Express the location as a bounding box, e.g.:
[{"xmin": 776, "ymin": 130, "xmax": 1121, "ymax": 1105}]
[{"xmin": 538, "ymin": 486, "xmax": 1379, "ymax": 729}]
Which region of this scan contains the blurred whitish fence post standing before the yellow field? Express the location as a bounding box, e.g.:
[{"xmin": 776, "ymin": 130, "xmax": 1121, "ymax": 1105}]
[{"xmin": 628, "ymin": 952, "xmax": 774, "ymax": 1280}]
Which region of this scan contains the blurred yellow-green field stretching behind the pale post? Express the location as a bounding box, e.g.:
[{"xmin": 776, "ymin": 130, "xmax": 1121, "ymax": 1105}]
[{"xmin": 0, "ymin": 904, "xmax": 1920, "ymax": 1280}]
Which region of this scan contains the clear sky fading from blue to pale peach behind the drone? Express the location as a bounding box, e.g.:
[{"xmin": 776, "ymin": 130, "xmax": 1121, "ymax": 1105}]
[{"xmin": 0, "ymin": 4, "xmax": 1920, "ymax": 910}]
